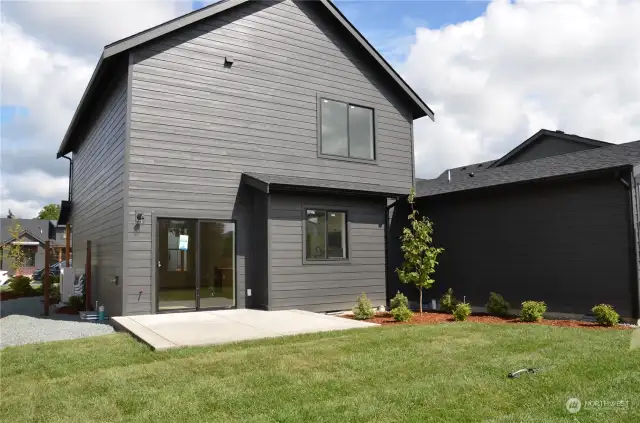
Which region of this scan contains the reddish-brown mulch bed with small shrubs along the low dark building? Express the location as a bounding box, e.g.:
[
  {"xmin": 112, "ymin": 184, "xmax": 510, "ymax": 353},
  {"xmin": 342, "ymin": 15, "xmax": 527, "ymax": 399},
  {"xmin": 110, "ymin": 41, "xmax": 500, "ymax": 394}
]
[{"xmin": 341, "ymin": 312, "xmax": 634, "ymax": 329}]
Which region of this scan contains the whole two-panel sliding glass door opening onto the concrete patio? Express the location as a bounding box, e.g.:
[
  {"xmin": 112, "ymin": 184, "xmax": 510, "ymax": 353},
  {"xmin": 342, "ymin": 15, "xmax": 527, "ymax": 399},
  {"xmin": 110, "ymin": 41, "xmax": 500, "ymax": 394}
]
[{"xmin": 156, "ymin": 218, "xmax": 236, "ymax": 312}]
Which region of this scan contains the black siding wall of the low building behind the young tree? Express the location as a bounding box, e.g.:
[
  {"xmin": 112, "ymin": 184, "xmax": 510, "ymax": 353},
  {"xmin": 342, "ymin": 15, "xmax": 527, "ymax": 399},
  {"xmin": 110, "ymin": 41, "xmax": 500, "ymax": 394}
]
[{"xmin": 391, "ymin": 173, "xmax": 635, "ymax": 316}]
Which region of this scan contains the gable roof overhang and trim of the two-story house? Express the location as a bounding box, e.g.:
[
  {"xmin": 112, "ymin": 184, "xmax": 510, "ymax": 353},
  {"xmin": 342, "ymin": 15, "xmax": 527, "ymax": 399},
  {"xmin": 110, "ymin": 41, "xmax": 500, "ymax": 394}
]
[{"xmin": 57, "ymin": 0, "xmax": 435, "ymax": 158}]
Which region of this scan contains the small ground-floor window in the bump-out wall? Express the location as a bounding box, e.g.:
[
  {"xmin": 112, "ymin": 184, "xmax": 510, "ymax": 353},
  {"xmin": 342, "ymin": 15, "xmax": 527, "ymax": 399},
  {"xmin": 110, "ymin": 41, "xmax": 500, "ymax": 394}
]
[{"xmin": 304, "ymin": 209, "xmax": 347, "ymax": 260}]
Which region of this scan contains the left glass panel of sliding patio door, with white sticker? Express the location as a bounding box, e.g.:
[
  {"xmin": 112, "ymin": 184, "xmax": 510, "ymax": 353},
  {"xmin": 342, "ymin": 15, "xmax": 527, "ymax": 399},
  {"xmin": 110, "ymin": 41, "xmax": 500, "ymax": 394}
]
[{"xmin": 156, "ymin": 219, "xmax": 197, "ymax": 311}]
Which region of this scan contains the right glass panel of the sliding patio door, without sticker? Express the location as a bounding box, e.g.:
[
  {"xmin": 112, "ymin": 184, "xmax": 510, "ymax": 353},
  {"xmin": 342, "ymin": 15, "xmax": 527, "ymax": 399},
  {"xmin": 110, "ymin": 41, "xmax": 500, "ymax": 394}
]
[{"xmin": 198, "ymin": 221, "xmax": 236, "ymax": 308}]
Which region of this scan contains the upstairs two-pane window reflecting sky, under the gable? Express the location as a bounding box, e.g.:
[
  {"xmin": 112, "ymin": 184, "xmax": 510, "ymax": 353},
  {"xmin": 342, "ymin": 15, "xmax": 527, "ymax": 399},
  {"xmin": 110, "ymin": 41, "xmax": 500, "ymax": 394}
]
[{"xmin": 320, "ymin": 98, "xmax": 375, "ymax": 160}]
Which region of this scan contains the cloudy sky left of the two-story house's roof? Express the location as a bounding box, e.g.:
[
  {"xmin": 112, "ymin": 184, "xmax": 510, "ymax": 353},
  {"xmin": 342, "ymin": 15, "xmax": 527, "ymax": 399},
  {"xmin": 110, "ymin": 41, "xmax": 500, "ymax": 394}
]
[{"xmin": 0, "ymin": 0, "xmax": 191, "ymax": 217}]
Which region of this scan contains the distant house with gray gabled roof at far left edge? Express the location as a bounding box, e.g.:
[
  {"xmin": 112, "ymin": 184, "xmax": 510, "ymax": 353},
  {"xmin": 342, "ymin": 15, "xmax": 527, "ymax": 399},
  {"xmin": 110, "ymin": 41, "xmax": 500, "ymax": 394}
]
[{"xmin": 0, "ymin": 218, "xmax": 55, "ymax": 275}]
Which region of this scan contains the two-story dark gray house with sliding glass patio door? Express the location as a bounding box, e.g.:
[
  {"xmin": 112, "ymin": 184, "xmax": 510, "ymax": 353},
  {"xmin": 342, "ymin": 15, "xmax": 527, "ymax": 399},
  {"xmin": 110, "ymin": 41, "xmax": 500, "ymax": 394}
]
[{"xmin": 58, "ymin": 0, "xmax": 433, "ymax": 315}]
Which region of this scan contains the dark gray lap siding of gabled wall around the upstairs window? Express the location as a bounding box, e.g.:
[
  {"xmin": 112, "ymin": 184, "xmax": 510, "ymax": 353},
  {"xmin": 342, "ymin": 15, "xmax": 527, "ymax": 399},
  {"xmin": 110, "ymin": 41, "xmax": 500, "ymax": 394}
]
[{"xmin": 125, "ymin": 1, "xmax": 413, "ymax": 313}]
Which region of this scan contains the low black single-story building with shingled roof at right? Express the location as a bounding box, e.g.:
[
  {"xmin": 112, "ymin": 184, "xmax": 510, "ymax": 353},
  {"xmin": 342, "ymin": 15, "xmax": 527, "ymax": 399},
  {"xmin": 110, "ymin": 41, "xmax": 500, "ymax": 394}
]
[{"xmin": 389, "ymin": 130, "xmax": 640, "ymax": 319}]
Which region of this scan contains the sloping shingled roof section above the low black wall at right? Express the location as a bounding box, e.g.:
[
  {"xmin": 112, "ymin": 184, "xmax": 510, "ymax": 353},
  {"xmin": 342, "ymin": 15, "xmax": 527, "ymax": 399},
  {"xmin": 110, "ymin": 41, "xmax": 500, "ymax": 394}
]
[{"xmin": 416, "ymin": 141, "xmax": 640, "ymax": 197}]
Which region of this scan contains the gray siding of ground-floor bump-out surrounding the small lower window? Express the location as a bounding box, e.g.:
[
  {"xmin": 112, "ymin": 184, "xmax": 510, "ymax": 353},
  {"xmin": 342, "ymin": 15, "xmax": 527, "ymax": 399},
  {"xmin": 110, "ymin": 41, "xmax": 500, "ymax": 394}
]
[{"xmin": 269, "ymin": 194, "xmax": 386, "ymax": 311}]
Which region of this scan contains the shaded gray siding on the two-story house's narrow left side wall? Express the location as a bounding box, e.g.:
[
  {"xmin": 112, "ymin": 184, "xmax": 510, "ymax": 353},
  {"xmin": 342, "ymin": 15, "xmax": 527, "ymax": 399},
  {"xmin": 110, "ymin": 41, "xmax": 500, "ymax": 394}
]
[{"xmin": 72, "ymin": 72, "xmax": 127, "ymax": 316}]
